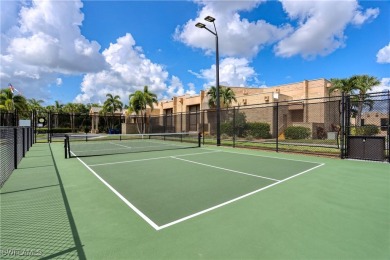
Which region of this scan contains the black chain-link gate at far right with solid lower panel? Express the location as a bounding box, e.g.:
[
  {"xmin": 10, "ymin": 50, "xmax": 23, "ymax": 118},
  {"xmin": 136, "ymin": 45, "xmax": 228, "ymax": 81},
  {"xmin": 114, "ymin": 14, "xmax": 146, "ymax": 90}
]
[{"xmin": 341, "ymin": 92, "xmax": 390, "ymax": 162}]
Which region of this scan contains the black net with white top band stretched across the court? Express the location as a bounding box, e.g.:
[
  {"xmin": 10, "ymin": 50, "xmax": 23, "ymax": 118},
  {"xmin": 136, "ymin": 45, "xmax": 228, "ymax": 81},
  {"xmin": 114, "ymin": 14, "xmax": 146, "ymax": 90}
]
[{"xmin": 64, "ymin": 133, "xmax": 200, "ymax": 158}]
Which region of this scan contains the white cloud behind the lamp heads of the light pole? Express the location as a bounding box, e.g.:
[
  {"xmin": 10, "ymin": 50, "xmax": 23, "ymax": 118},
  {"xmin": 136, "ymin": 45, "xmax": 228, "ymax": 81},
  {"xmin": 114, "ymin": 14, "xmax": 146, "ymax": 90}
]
[{"xmin": 174, "ymin": 1, "xmax": 291, "ymax": 58}]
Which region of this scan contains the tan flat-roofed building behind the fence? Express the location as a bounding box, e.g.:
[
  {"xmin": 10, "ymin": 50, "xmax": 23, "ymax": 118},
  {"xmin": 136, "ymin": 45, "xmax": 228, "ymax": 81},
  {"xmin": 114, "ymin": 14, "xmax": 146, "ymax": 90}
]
[{"xmin": 155, "ymin": 79, "xmax": 339, "ymax": 138}]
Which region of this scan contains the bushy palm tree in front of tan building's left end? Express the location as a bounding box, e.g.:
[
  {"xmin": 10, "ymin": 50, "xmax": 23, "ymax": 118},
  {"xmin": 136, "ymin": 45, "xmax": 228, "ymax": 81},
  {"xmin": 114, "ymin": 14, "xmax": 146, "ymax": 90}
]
[{"xmin": 129, "ymin": 86, "xmax": 158, "ymax": 133}]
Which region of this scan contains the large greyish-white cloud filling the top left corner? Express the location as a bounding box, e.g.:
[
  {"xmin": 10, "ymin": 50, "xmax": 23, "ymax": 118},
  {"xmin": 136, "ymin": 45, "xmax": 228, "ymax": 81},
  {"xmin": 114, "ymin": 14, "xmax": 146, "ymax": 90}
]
[{"xmin": 0, "ymin": 0, "xmax": 106, "ymax": 99}]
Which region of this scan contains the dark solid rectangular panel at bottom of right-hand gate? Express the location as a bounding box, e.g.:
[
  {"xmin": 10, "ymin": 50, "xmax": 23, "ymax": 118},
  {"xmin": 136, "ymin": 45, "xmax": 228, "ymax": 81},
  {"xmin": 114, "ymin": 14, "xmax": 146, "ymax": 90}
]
[{"xmin": 348, "ymin": 136, "xmax": 386, "ymax": 161}]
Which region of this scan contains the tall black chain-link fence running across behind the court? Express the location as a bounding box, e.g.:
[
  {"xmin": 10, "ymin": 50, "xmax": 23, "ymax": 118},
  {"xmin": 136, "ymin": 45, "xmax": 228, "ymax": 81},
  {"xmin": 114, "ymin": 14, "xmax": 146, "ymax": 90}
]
[{"xmin": 0, "ymin": 92, "xmax": 390, "ymax": 162}]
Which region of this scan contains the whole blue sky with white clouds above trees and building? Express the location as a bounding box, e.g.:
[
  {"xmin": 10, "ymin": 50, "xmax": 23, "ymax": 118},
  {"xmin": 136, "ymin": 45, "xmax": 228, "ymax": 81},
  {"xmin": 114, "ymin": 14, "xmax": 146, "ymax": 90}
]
[{"xmin": 0, "ymin": 0, "xmax": 390, "ymax": 105}]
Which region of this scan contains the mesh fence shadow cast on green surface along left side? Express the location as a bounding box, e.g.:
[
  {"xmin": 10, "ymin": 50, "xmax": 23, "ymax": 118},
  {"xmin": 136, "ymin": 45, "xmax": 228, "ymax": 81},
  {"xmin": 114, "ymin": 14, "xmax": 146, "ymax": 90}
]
[{"xmin": 0, "ymin": 144, "xmax": 85, "ymax": 259}]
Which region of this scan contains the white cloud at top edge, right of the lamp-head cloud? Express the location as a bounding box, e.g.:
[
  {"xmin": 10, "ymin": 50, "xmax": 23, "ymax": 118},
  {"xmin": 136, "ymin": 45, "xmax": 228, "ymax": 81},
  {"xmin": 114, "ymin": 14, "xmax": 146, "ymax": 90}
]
[{"xmin": 274, "ymin": 0, "xmax": 379, "ymax": 58}]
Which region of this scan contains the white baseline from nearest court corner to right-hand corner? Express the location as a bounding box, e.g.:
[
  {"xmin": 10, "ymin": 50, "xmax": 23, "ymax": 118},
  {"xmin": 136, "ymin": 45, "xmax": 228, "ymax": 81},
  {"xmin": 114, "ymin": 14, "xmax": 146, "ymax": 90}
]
[{"xmin": 157, "ymin": 163, "xmax": 324, "ymax": 230}]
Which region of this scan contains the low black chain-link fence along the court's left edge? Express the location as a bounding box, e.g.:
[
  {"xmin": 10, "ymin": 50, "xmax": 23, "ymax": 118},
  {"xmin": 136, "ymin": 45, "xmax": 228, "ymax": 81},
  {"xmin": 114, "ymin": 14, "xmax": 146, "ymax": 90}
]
[{"xmin": 0, "ymin": 126, "xmax": 34, "ymax": 188}]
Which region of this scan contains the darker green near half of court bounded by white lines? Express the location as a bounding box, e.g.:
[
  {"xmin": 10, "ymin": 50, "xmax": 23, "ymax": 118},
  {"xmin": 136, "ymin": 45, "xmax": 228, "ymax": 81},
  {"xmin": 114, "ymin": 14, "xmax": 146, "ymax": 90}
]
[{"xmin": 74, "ymin": 143, "xmax": 322, "ymax": 230}]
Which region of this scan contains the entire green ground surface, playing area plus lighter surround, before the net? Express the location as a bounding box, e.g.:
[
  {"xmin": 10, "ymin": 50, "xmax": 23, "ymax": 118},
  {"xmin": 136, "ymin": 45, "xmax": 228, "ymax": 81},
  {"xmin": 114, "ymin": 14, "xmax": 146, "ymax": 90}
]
[{"xmin": 0, "ymin": 143, "xmax": 390, "ymax": 259}]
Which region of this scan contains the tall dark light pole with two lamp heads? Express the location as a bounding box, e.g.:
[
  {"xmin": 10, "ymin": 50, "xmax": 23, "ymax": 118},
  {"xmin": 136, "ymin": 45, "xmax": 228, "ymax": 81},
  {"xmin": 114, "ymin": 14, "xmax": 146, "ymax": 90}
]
[{"xmin": 195, "ymin": 16, "xmax": 221, "ymax": 146}]
